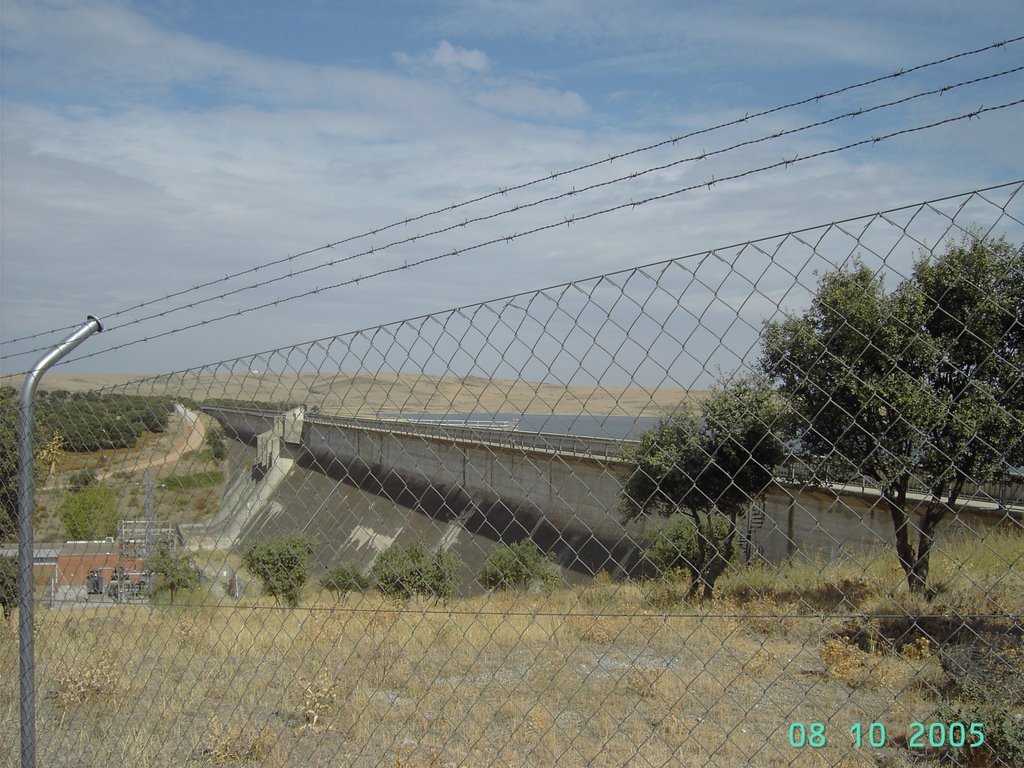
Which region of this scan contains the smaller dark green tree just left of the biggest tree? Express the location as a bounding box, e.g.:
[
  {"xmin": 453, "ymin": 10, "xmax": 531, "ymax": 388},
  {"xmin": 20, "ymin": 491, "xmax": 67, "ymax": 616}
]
[{"xmin": 618, "ymin": 376, "xmax": 786, "ymax": 598}]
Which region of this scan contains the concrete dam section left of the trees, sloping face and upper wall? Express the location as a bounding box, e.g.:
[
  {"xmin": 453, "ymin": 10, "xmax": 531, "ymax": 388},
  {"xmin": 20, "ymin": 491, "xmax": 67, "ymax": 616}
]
[{"xmin": 190, "ymin": 407, "xmax": 643, "ymax": 580}]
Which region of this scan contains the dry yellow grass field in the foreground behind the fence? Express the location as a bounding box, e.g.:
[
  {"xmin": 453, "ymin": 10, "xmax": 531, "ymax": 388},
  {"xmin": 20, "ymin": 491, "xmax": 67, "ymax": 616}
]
[{"xmin": 0, "ymin": 583, "xmax": 1007, "ymax": 768}]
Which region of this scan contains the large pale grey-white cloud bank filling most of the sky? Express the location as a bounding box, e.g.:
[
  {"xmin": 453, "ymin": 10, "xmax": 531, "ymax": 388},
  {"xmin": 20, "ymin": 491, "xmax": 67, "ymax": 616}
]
[{"xmin": 0, "ymin": 0, "xmax": 1020, "ymax": 371}]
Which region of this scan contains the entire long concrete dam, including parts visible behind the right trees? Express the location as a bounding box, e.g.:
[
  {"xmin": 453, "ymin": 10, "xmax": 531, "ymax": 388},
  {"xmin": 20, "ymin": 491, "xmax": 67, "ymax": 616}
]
[{"xmin": 191, "ymin": 407, "xmax": 1024, "ymax": 584}]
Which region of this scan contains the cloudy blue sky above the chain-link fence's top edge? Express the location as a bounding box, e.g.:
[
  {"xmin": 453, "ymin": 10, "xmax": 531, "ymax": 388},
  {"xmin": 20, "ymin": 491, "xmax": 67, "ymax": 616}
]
[{"xmin": 0, "ymin": 0, "xmax": 1024, "ymax": 391}]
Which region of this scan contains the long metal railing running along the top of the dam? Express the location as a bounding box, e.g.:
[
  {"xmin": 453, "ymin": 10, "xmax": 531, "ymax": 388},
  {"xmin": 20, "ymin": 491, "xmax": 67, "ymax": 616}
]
[{"xmin": 203, "ymin": 406, "xmax": 1024, "ymax": 515}]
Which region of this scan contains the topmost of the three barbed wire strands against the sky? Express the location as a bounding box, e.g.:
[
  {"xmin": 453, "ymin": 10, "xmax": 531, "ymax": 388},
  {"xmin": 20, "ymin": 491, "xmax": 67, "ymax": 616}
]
[{"xmin": 0, "ymin": 36, "xmax": 1024, "ymax": 348}]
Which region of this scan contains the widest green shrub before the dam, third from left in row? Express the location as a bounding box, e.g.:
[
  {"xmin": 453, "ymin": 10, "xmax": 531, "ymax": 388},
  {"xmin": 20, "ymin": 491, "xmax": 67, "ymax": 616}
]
[{"xmin": 371, "ymin": 542, "xmax": 463, "ymax": 600}]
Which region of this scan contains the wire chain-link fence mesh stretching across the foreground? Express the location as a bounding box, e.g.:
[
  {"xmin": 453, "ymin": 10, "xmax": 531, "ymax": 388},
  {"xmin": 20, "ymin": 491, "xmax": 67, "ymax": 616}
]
[{"xmin": 6, "ymin": 182, "xmax": 1024, "ymax": 768}]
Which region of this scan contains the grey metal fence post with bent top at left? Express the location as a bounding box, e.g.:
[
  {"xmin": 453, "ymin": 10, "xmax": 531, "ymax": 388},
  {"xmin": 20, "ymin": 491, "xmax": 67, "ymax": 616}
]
[{"xmin": 17, "ymin": 314, "xmax": 103, "ymax": 768}]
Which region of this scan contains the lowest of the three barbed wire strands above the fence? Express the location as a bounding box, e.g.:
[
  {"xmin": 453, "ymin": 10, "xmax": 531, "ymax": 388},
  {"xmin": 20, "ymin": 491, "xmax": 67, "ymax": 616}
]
[{"xmin": 25, "ymin": 98, "xmax": 1024, "ymax": 372}]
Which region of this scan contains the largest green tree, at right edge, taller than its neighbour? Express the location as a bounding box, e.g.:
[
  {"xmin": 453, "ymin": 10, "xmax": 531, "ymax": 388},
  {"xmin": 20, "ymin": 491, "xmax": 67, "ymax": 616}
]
[{"xmin": 762, "ymin": 236, "xmax": 1024, "ymax": 592}]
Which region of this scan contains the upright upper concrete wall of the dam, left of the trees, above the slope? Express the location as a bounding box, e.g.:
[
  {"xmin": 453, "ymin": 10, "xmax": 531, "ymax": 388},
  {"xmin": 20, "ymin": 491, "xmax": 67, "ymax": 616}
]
[{"xmin": 204, "ymin": 407, "xmax": 641, "ymax": 572}]
